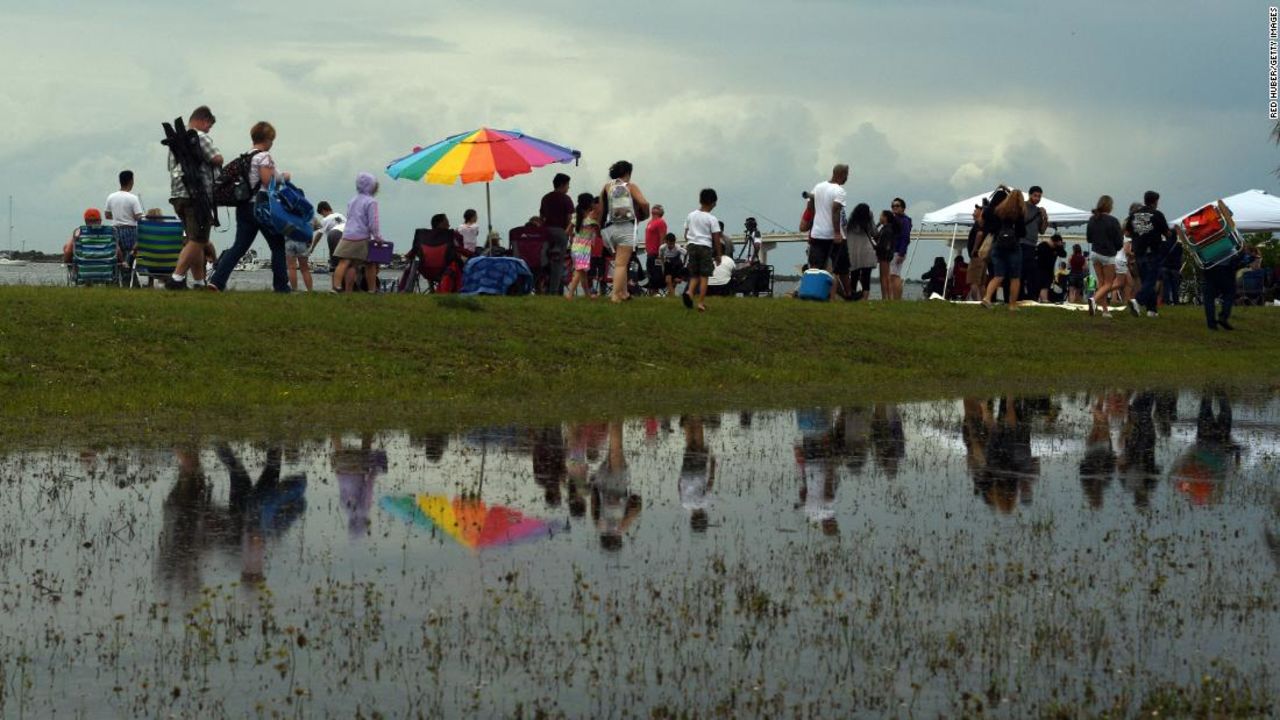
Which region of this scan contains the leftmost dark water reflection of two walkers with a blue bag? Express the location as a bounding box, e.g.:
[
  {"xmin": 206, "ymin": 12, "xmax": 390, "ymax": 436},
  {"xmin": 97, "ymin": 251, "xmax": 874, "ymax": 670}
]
[{"xmin": 157, "ymin": 443, "xmax": 307, "ymax": 593}]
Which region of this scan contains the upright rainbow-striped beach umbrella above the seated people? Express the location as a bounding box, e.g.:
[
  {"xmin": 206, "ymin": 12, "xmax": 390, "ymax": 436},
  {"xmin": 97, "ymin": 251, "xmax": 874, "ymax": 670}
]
[{"xmin": 387, "ymin": 128, "xmax": 582, "ymax": 232}]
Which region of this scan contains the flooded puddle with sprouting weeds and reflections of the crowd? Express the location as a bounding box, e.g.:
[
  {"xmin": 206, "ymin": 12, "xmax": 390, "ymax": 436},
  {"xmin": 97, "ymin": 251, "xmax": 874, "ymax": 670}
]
[{"xmin": 0, "ymin": 392, "xmax": 1280, "ymax": 717}]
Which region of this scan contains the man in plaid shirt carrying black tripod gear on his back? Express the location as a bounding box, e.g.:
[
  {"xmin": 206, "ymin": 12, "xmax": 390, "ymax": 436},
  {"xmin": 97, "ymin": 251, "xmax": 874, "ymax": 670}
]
[{"xmin": 164, "ymin": 105, "xmax": 223, "ymax": 290}]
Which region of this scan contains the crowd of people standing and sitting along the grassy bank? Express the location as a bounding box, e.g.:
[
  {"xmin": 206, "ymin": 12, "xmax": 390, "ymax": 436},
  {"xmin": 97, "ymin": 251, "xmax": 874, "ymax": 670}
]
[{"xmin": 64, "ymin": 106, "xmax": 1257, "ymax": 329}]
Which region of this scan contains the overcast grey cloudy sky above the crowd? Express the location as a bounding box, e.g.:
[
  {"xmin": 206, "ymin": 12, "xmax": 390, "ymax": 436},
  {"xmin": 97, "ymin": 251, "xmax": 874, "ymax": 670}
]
[{"xmin": 0, "ymin": 0, "xmax": 1280, "ymax": 263}]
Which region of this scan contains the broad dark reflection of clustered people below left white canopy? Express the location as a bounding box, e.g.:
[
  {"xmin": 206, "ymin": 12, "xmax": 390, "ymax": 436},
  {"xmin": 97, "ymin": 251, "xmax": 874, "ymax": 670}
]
[{"xmin": 961, "ymin": 397, "xmax": 1053, "ymax": 514}]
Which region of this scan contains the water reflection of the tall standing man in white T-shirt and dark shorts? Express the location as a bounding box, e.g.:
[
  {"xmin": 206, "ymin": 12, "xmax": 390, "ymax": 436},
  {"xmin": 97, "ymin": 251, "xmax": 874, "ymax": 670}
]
[{"xmin": 795, "ymin": 409, "xmax": 845, "ymax": 536}]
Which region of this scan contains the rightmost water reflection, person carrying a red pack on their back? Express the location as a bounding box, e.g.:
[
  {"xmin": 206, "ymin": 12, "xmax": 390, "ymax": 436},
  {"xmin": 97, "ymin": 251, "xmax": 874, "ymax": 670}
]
[{"xmin": 1170, "ymin": 392, "xmax": 1240, "ymax": 505}]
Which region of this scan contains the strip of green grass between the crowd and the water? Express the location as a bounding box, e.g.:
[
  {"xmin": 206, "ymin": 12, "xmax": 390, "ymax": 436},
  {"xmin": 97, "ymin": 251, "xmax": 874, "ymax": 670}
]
[{"xmin": 0, "ymin": 287, "xmax": 1280, "ymax": 442}]
